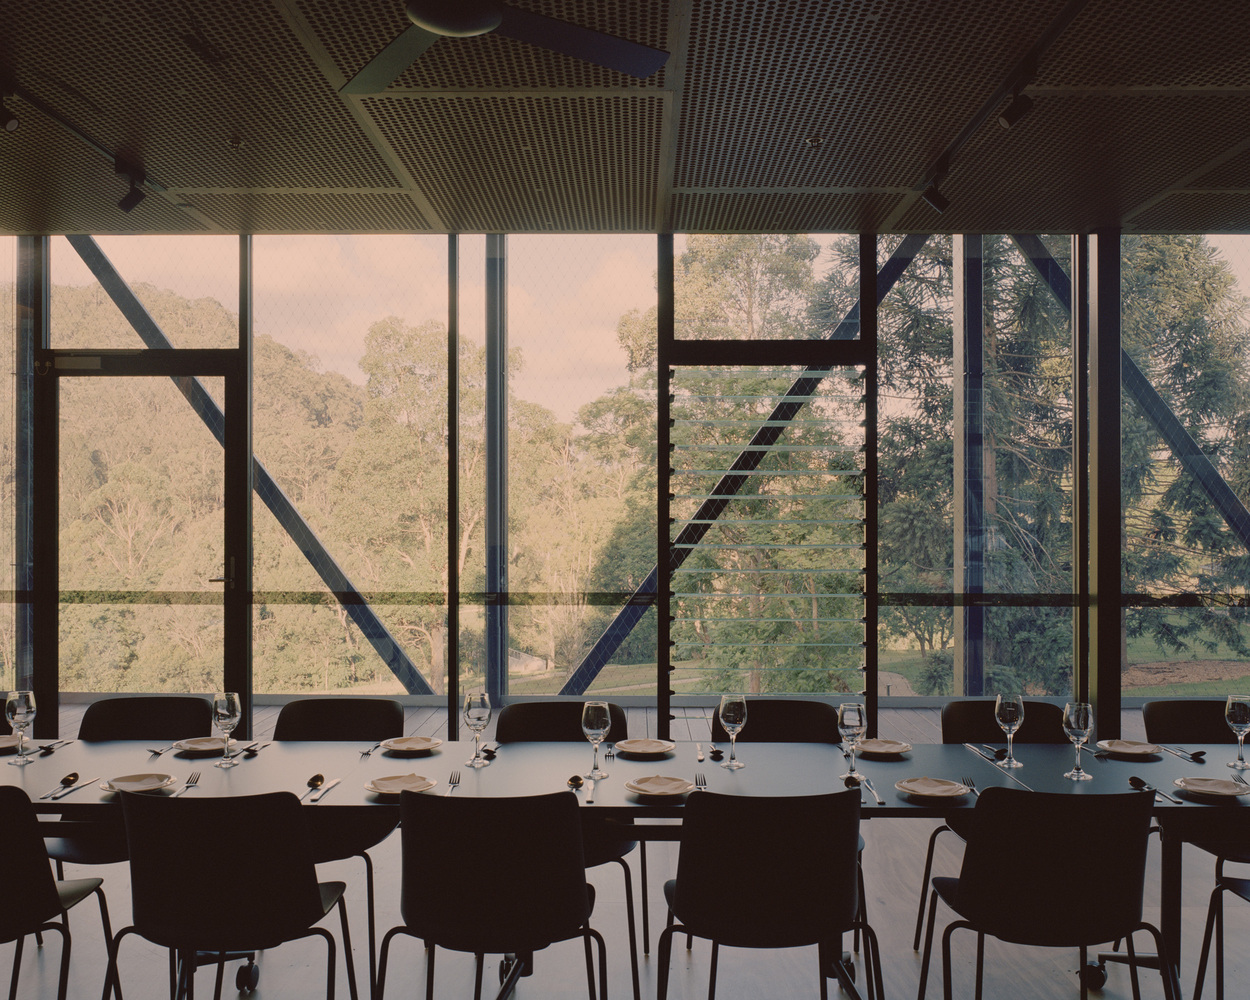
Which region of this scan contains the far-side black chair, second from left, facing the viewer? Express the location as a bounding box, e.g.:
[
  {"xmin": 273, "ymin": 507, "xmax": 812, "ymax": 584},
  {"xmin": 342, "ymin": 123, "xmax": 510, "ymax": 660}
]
[{"xmin": 274, "ymin": 698, "xmax": 404, "ymax": 990}]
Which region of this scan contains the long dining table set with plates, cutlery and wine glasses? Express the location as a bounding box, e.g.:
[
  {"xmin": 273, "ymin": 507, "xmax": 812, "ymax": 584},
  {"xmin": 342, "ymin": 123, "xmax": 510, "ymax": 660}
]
[{"xmin": 7, "ymin": 740, "xmax": 1250, "ymax": 985}]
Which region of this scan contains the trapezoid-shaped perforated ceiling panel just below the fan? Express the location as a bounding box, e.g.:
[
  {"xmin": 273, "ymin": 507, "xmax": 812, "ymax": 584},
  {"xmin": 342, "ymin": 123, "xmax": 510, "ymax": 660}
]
[{"xmin": 366, "ymin": 95, "xmax": 664, "ymax": 233}]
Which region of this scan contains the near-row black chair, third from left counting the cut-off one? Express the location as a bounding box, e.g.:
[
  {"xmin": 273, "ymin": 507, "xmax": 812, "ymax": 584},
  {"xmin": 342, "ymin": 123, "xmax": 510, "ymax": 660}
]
[{"xmin": 375, "ymin": 791, "xmax": 608, "ymax": 1000}]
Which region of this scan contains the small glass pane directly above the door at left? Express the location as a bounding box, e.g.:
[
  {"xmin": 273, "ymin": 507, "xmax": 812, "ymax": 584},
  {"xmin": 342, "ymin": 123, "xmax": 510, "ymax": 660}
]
[{"xmin": 51, "ymin": 235, "xmax": 239, "ymax": 350}]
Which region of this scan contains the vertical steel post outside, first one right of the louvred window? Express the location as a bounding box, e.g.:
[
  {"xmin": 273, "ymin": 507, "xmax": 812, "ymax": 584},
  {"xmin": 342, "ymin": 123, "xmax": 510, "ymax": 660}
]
[{"xmin": 953, "ymin": 235, "xmax": 985, "ymax": 695}]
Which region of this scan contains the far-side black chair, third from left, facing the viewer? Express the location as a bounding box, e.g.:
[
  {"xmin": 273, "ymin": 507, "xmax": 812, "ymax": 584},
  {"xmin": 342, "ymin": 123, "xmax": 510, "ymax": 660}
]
[{"xmin": 495, "ymin": 701, "xmax": 651, "ymax": 1000}]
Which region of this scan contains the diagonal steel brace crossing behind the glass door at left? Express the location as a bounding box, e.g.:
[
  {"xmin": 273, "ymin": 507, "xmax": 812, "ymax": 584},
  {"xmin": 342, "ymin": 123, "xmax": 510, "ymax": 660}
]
[{"xmin": 67, "ymin": 236, "xmax": 433, "ymax": 695}]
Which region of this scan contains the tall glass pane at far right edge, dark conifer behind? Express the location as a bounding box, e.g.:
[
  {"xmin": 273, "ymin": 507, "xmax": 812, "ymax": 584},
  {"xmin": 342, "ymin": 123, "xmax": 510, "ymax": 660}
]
[{"xmin": 1120, "ymin": 235, "xmax": 1250, "ymax": 698}]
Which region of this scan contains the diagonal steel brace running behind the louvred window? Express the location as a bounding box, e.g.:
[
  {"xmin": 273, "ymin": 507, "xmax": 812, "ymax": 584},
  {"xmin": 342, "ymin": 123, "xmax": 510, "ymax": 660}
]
[{"xmin": 560, "ymin": 234, "xmax": 929, "ymax": 695}]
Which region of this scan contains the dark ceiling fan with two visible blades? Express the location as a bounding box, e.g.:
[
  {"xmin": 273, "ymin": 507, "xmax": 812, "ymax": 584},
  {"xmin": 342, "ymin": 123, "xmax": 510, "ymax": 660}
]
[{"xmin": 339, "ymin": 0, "xmax": 669, "ymax": 94}]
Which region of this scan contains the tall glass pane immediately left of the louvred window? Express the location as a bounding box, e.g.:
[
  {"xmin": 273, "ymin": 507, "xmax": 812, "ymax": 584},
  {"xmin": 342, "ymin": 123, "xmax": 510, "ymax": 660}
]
[{"xmin": 508, "ymin": 236, "xmax": 655, "ymax": 695}]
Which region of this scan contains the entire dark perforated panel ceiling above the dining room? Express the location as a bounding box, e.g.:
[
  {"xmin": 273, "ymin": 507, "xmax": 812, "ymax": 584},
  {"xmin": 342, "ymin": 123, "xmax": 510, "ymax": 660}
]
[{"xmin": 0, "ymin": 0, "xmax": 1250, "ymax": 233}]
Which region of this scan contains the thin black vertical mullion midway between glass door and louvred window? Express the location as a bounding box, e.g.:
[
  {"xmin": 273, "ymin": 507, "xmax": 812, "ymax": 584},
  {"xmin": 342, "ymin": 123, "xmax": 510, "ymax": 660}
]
[{"xmin": 444, "ymin": 233, "xmax": 460, "ymax": 740}]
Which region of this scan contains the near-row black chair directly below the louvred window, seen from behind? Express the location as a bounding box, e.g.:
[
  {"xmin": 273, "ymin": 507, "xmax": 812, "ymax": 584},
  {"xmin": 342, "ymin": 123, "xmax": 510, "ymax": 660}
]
[{"xmin": 658, "ymin": 790, "xmax": 883, "ymax": 1000}]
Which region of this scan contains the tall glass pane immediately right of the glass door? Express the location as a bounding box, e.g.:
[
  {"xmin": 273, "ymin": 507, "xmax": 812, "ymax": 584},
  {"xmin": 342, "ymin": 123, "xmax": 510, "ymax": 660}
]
[{"xmin": 253, "ymin": 235, "xmax": 448, "ymax": 694}]
